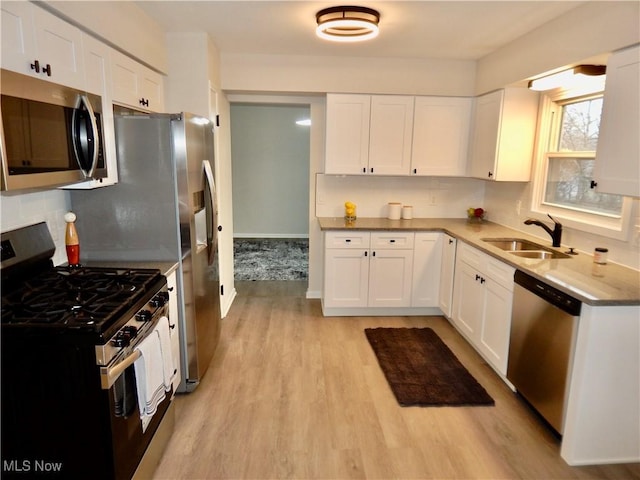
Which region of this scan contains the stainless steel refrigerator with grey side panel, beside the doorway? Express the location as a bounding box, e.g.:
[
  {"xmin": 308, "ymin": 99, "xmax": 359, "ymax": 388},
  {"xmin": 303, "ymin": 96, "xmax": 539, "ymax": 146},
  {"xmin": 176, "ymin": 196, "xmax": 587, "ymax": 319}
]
[{"xmin": 70, "ymin": 113, "xmax": 220, "ymax": 392}]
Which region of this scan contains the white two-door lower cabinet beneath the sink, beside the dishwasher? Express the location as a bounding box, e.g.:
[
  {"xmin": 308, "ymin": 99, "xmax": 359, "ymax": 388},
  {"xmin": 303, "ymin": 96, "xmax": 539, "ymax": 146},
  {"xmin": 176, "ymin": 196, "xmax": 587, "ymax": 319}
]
[{"xmin": 452, "ymin": 242, "xmax": 515, "ymax": 376}]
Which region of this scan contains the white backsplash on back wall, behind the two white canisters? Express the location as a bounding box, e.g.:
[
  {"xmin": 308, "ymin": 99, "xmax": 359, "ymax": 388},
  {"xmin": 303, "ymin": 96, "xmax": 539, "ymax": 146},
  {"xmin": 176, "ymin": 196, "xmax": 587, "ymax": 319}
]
[{"xmin": 316, "ymin": 174, "xmax": 484, "ymax": 219}]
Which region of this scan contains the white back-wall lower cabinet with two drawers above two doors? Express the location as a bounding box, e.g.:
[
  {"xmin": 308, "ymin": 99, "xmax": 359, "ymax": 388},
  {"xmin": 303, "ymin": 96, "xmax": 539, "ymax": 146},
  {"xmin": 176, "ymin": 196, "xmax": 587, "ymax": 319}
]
[{"xmin": 323, "ymin": 231, "xmax": 414, "ymax": 308}]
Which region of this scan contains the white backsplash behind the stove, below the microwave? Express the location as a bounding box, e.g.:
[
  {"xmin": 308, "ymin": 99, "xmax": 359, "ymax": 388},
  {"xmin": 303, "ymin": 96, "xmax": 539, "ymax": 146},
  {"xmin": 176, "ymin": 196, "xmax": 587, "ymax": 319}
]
[{"xmin": 0, "ymin": 190, "xmax": 71, "ymax": 265}]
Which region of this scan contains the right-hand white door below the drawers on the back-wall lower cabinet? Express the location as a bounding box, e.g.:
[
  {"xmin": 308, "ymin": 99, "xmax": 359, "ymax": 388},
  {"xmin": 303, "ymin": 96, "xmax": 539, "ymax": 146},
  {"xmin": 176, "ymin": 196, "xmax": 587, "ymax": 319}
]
[{"xmin": 368, "ymin": 249, "xmax": 413, "ymax": 307}]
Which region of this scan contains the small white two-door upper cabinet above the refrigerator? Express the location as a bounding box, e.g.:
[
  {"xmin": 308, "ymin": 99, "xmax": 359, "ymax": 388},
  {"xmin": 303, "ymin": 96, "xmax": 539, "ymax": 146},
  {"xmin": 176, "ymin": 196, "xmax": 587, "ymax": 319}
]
[{"xmin": 111, "ymin": 50, "xmax": 164, "ymax": 112}]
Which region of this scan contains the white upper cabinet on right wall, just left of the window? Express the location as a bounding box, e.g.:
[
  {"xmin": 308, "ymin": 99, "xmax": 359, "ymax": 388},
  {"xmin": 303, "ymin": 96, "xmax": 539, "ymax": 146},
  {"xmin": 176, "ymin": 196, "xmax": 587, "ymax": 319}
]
[{"xmin": 469, "ymin": 88, "xmax": 538, "ymax": 182}]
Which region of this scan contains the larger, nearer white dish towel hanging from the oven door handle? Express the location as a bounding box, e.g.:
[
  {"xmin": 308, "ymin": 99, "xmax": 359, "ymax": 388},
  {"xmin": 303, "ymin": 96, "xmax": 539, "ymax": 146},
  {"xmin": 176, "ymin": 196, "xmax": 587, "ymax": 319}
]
[{"xmin": 133, "ymin": 327, "xmax": 165, "ymax": 432}]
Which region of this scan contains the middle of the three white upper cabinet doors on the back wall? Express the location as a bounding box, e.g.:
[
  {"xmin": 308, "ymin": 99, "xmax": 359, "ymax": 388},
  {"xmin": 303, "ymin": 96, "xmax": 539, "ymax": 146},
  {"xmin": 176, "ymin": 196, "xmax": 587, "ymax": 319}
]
[{"xmin": 369, "ymin": 95, "xmax": 413, "ymax": 175}]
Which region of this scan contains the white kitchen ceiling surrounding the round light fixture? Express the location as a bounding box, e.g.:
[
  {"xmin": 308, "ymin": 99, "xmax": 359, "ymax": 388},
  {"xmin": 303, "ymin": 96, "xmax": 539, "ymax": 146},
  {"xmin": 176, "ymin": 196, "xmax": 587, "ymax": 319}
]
[{"xmin": 136, "ymin": 0, "xmax": 584, "ymax": 60}]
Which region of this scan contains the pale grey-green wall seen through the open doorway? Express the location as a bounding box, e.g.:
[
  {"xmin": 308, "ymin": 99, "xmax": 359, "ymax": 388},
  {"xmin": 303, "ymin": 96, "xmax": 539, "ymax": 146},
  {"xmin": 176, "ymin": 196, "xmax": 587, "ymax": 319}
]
[{"xmin": 231, "ymin": 103, "xmax": 310, "ymax": 238}]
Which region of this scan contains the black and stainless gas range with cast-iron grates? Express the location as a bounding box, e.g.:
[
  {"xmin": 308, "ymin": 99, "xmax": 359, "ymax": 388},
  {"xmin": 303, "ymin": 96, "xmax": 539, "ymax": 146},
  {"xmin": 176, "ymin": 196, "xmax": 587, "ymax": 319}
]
[{"xmin": 0, "ymin": 223, "xmax": 173, "ymax": 479}]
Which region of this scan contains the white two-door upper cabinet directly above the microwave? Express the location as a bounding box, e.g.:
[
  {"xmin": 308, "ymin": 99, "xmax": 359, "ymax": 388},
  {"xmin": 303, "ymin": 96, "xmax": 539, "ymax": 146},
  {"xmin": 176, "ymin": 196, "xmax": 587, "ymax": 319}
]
[{"xmin": 1, "ymin": 2, "xmax": 85, "ymax": 89}]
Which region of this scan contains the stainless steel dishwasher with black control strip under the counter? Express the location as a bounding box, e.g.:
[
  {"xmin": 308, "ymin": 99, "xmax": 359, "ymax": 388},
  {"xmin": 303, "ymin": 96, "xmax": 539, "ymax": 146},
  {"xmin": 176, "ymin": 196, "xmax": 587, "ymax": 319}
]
[{"xmin": 507, "ymin": 270, "xmax": 582, "ymax": 434}]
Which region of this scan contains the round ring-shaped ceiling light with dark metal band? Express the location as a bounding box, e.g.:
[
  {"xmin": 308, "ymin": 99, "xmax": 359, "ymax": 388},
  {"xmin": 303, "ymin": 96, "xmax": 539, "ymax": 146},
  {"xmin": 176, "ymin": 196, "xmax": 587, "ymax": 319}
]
[{"xmin": 316, "ymin": 7, "xmax": 380, "ymax": 42}]
